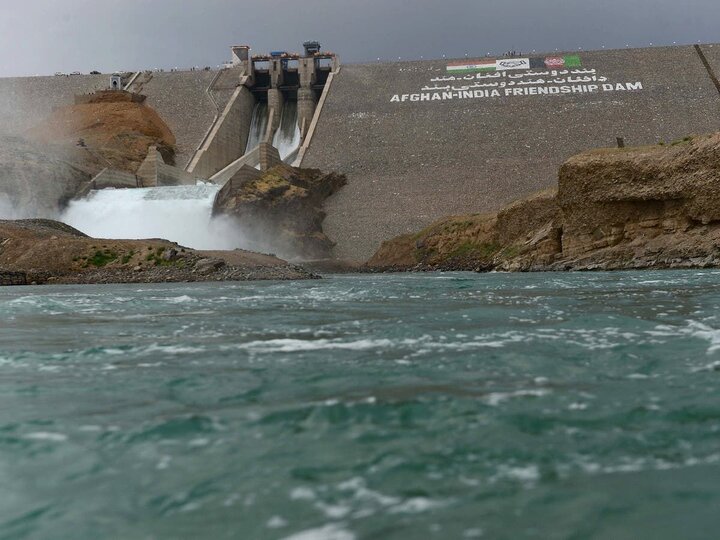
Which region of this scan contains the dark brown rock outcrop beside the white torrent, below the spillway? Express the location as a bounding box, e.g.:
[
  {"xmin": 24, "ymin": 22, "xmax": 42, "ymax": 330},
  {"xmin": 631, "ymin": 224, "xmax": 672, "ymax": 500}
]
[{"xmin": 214, "ymin": 164, "xmax": 346, "ymax": 260}]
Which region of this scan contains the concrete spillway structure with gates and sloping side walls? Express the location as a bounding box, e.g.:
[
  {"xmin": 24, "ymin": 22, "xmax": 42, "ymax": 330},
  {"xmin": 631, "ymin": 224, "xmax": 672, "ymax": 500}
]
[{"xmin": 187, "ymin": 42, "xmax": 339, "ymax": 185}]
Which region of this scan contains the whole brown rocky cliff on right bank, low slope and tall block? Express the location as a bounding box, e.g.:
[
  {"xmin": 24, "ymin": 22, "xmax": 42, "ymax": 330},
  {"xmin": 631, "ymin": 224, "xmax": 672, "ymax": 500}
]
[{"xmin": 368, "ymin": 134, "xmax": 720, "ymax": 271}]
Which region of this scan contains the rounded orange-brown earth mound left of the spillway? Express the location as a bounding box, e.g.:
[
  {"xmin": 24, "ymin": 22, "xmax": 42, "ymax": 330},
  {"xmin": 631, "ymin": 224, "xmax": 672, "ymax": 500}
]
[{"xmin": 28, "ymin": 92, "xmax": 175, "ymax": 173}]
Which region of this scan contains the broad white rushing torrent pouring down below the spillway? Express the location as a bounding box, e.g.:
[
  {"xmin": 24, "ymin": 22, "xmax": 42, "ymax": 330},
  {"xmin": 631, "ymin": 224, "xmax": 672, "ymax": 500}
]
[{"xmin": 62, "ymin": 184, "xmax": 243, "ymax": 249}]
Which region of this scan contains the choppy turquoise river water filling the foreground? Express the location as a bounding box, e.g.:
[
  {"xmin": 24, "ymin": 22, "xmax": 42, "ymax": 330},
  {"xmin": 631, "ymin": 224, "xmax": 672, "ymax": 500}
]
[{"xmin": 0, "ymin": 271, "xmax": 720, "ymax": 540}]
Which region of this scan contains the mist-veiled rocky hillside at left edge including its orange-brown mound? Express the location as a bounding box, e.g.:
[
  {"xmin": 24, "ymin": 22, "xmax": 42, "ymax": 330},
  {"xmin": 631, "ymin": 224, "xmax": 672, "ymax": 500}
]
[{"xmin": 0, "ymin": 92, "xmax": 175, "ymax": 218}]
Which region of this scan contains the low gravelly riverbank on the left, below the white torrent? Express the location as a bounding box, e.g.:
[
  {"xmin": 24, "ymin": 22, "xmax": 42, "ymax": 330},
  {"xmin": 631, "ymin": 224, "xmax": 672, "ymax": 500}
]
[{"xmin": 0, "ymin": 220, "xmax": 318, "ymax": 285}]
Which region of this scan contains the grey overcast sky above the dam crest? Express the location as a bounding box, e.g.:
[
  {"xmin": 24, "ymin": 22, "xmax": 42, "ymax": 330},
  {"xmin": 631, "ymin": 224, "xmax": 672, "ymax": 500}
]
[{"xmin": 0, "ymin": 0, "xmax": 720, "ymax": 76}]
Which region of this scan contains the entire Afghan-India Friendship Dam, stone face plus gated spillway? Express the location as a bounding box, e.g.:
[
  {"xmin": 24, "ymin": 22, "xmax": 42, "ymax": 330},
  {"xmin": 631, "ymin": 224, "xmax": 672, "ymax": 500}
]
[{"xmin": 0, "ymin": 42, "xmax": 720, "ymax": 261}]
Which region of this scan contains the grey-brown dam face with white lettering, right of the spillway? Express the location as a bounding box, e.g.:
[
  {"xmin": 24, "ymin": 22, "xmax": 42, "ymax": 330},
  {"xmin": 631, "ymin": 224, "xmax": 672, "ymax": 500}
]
[{"xmin": 302, "ymin": 45, "xmax": 720, "ymax": 261}]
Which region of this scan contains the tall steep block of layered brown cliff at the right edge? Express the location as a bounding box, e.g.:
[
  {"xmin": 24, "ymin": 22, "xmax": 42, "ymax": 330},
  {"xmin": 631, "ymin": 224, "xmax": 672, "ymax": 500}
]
[{"xmin": 557, "ymin": 134, "xmax": 720, "ymax": 257}]
